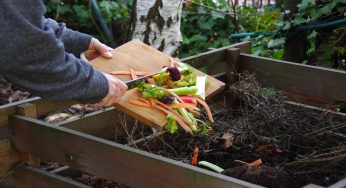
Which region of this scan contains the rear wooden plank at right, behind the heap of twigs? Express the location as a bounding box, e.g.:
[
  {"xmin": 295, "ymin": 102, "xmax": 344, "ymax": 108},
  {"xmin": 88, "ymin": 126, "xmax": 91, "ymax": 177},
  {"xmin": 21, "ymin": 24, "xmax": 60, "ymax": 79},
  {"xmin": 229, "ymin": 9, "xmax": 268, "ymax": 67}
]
[{"xmin": 240, "ymin": 54, "xmax": 346, "ymax": 101}]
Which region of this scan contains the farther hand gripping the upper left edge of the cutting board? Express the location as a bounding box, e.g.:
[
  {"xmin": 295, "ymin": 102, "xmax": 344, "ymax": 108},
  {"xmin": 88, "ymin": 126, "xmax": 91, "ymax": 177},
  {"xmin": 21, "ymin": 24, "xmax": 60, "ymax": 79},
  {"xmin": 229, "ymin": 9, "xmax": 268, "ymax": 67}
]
[{"xmin": 85, "ymin": 38, "xmax": 112, "ymax": 61}]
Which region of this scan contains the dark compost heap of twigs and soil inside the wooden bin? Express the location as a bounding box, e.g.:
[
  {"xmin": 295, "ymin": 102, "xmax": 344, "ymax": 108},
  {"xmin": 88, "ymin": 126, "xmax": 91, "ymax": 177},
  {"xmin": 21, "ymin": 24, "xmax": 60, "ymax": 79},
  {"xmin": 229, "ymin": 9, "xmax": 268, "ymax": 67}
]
[{"xmin": 133, "ymin": 74, "xmax": 346, "ymax": 187}]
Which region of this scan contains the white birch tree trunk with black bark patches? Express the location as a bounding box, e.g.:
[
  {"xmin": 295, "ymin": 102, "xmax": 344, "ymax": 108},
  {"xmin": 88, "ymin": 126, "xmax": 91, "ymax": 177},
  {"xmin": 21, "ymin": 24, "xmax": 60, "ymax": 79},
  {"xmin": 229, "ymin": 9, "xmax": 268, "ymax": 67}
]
[{"xmin": 132, "ymin": 0, "xmax": 183, "ymax": 56}]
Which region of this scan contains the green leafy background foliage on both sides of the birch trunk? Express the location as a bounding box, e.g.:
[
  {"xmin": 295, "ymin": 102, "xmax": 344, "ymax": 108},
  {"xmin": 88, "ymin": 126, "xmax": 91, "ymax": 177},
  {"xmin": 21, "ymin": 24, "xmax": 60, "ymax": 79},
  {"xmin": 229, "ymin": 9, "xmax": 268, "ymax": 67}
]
[{"xmin": 45, "ymin": 0, "xmax": 346, "ymax": 68}]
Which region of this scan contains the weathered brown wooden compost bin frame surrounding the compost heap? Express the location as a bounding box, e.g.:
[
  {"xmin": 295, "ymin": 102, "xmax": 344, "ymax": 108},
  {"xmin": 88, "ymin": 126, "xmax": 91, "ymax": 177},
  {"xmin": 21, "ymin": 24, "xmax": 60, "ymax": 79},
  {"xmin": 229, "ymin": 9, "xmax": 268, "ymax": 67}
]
[{"xmin": 0, "ymin": 42, "xmax": 346, "ymax": 188}]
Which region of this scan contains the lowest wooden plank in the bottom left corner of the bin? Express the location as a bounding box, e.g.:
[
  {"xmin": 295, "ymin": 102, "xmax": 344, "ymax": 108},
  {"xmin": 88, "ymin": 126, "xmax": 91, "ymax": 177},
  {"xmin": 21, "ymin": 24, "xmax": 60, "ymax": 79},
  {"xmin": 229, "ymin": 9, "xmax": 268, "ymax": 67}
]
[{"xmin": 0, "ymin": 167, "xmax": 91, "ymax": 188}]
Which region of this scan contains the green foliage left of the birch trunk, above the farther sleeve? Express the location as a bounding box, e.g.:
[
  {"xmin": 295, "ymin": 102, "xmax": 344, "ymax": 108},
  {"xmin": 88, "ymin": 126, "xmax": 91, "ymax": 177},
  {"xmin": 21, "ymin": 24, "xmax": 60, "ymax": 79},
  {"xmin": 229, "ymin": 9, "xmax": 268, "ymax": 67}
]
[{"xmin": 44, "ymin": 0, "xmax": 132, "ymax": 43}]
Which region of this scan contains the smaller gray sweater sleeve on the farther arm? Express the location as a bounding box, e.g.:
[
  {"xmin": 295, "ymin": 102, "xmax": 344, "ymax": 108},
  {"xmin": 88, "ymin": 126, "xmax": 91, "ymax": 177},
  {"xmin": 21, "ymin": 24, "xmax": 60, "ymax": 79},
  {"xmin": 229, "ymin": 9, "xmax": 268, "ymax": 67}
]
[{"xmin": 44, "ymin": 18, "xmax": 92, "ymax": 57}]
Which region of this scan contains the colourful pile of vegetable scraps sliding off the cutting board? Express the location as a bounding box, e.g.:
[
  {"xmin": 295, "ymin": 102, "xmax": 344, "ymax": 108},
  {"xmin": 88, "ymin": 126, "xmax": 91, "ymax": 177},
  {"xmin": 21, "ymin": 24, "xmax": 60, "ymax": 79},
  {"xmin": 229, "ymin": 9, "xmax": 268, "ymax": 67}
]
[{"xmin": 127, "ymin": 59, "xmax": 214, "ymax": 134}]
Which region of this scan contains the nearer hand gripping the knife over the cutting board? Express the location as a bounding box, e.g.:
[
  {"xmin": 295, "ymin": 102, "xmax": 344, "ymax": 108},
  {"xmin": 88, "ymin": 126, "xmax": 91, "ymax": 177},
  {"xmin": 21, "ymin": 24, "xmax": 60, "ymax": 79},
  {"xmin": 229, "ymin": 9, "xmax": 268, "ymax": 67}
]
[{"xmin": 88, "ymin": 74, "xmax": 127, "ymax": 107}]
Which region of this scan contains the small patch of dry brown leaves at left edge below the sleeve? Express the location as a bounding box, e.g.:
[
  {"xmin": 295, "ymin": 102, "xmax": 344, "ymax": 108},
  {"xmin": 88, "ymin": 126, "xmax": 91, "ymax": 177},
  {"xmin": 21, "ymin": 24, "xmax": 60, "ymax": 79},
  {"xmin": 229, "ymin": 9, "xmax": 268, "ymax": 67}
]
[{"xmin": 0, "ymin": 75, "xmax": 30, "ymax": 105}]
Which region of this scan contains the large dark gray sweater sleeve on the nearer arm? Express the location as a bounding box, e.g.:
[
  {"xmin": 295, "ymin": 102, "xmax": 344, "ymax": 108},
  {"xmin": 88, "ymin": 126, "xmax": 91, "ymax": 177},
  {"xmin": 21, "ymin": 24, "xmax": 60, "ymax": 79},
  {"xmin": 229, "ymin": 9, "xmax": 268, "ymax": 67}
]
[{"xmin": 0, "ymin": 0, "xmax": 108, "ymax": 102}]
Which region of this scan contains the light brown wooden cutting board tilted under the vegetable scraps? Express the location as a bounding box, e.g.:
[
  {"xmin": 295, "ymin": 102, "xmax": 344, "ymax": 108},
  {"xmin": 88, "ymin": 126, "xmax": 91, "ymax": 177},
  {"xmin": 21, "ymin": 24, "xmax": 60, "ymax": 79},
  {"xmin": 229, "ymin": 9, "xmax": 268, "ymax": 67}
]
[{"xmin": 91, "ymin": 40, "xmax": 225, "ymax": 131}]
